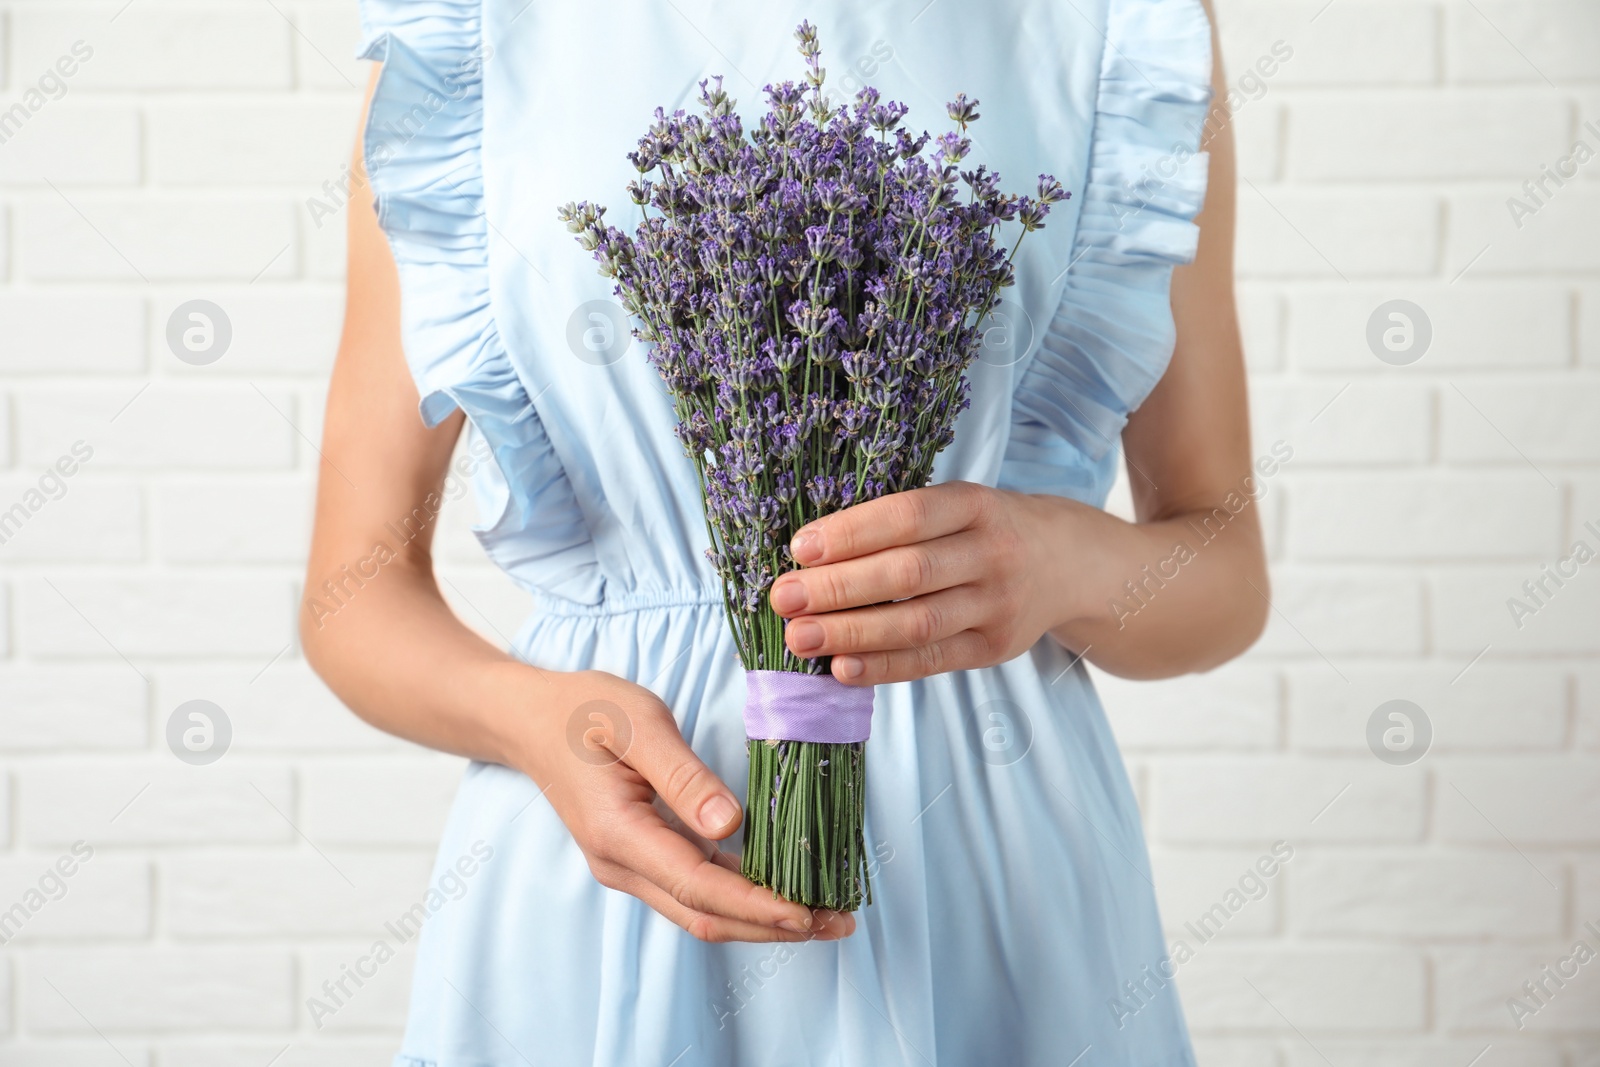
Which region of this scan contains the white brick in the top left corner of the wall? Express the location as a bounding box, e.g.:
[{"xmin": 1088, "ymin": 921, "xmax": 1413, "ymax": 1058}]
[{"xmin": 11, "ymin": 3, "xmax": 291, "ymax": 91}]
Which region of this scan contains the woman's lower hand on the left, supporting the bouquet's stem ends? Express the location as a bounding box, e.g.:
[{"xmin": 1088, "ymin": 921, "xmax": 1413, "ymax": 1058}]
[{"xmin": 517, "ymin": 670, "xmax": 856, "ymax": 942}]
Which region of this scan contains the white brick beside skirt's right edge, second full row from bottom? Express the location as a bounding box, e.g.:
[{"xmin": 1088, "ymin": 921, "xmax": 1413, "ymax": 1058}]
[{"xmin": 1150, "ymin": 848, "xmax": 1294, "ymax": 945}]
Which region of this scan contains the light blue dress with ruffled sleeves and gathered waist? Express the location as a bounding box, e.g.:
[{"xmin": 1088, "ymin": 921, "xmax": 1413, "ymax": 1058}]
[{"xmin": 363, "ymin": 0, "xmax": 1211, "ymax": 1067}]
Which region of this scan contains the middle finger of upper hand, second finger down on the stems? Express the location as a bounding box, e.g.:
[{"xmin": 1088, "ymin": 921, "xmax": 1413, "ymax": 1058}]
[{"xmin": 770, "ymin": 533, "xmax": 984, "ymax": 619}]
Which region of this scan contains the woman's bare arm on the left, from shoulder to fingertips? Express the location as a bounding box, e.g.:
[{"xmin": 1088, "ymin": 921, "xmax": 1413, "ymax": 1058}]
[{"xmin": 301, "ymin": 68, "xmax": 854, "ymax": 941}]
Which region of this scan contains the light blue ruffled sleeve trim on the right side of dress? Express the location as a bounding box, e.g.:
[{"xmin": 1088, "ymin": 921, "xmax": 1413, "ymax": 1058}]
[{"xmin": 1000, "ymin": 0, "xmax": 1211, "ymax": 504}]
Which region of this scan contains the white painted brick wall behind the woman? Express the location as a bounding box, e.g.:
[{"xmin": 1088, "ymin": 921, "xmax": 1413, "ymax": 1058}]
[{"xmin": 0, "ymin": 0, "xmax": 1600, "ymax": 1067}]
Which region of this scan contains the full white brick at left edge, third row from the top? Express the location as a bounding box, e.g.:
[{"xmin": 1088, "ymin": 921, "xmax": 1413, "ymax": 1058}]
[{"xmin": 16, "ymin": 194, "xmax": 298, "ymax": 283}]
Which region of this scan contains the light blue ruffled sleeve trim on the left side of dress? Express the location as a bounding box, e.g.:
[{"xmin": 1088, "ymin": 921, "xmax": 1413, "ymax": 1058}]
[{"xmin": 360, "ymin": 0, "xmax": 595, "ymax": 598}]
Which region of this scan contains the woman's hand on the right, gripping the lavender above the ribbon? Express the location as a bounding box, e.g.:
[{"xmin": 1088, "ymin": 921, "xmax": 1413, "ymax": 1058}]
[{"xmin": 770, "ymin": 482, "xmax": 1072, "ymax": 686}]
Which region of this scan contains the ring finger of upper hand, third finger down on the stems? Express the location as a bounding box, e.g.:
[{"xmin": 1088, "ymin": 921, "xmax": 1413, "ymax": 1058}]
[{"xmin": 784, "ymin": 585, "xmax": 989, "ymax": 659}]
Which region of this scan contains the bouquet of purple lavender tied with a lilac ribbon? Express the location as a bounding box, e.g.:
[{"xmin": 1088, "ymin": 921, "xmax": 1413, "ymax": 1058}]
[{"xmin": 560, "ymin": 22, "xmax": 1067, "ymax": 910}]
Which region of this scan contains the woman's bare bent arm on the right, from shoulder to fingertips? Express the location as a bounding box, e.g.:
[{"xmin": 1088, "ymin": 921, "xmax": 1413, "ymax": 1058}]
[{"xmin": 771, "ymin": 10, "xmax": 1267, "ymax": 685}]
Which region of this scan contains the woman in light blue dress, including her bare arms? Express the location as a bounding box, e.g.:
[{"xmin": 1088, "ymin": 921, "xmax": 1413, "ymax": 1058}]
[{"xmin": 302, "ymin": 0, "xmax": 1266, "ymax": 1067}]
